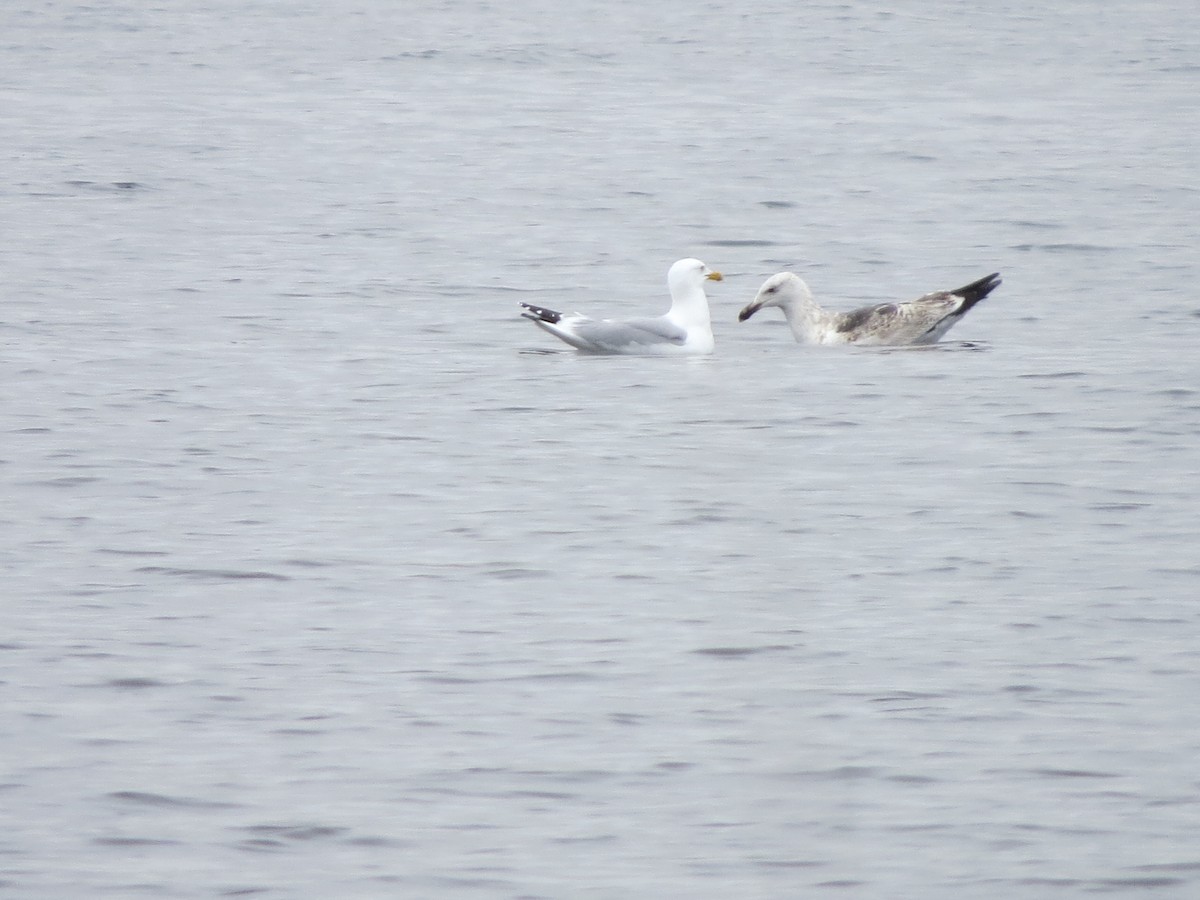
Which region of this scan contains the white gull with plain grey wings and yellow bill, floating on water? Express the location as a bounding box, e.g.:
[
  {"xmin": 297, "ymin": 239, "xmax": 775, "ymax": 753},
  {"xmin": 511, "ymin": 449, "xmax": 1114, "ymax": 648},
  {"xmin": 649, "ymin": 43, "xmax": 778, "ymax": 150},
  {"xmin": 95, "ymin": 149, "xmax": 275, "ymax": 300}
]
[{"xmin": 521, "ymin": 259, "xmax": 721, "ymax": 355}]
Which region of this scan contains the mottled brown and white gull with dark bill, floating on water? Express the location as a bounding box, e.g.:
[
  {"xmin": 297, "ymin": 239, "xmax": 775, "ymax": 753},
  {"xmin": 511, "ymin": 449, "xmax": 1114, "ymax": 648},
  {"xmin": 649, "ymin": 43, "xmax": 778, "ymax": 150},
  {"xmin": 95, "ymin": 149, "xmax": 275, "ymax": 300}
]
[{"xmin": 738, "ymin": 272, "xmax": 1000, "ymax": 347}]
